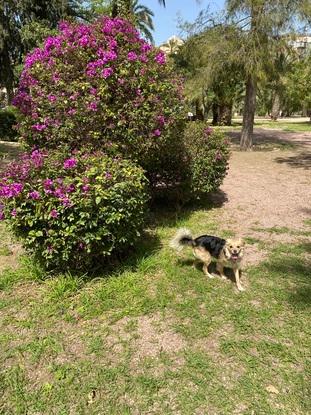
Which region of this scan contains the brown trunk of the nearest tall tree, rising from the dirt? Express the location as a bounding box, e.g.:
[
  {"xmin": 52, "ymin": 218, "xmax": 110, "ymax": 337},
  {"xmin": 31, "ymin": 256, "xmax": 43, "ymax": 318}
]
[{"xmin": 240, "ymin": 75, "xmax": 256, "ymax": 151}]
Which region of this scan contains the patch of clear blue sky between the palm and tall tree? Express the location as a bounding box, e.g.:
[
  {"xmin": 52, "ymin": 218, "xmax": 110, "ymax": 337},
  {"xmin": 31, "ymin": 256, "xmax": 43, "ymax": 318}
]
[{"xmin": 140, "ymin": 0, "xmax": 224, "ymax": 45}]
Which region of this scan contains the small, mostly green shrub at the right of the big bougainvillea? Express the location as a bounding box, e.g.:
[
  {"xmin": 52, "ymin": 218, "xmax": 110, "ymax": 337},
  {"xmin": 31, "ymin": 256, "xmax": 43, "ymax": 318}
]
[{"xmin": 184, "ymin": 121, "xmax": 229, "ymax": 196}]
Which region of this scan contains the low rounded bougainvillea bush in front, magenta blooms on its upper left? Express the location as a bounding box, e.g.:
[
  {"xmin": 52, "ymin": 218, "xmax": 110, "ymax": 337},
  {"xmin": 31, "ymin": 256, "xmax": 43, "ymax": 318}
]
[{"xmin": 0, "ymin": 150, "xmax": 147, "ymax": 269}]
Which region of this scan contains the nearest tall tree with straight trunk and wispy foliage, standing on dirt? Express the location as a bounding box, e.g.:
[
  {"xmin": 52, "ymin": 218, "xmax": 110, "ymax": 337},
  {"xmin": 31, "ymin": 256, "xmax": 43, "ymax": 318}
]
[{"xmin": 226, "ymin": 0, "xmax": 310, "ymax": 150}]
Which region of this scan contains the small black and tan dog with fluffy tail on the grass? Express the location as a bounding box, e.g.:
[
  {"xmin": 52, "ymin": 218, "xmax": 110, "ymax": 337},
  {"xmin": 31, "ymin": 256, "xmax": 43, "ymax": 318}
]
[{"xmin": 170, "ymin": 229, "xmax": 244, "ymax": 291}]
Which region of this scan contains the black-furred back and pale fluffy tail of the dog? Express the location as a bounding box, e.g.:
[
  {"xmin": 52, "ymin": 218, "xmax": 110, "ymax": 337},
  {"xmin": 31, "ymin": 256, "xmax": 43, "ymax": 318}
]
[{"xmin": 170, "ymin": 229, "xmax": 226, "ymax": 258}]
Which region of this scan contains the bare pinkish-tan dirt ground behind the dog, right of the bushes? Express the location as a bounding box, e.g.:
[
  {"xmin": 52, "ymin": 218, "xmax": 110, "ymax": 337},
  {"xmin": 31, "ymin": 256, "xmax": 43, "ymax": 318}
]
[{"xmin": 221, "ymin": 129, "xmax": 311, "ymax": 263}]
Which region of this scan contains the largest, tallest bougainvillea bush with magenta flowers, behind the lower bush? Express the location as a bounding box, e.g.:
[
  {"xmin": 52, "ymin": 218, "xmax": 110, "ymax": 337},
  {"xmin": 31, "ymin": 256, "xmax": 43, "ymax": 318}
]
[{"xmin": 14, "ymin": 16, "xmax": 184, "ymax": 184}]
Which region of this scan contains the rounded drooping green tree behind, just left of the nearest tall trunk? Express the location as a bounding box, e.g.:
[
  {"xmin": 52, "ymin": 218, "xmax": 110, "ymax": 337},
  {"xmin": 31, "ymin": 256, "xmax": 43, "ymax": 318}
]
[{"xmin": 174, "ymin": 26, "xmax": 243, "ymax": 125}]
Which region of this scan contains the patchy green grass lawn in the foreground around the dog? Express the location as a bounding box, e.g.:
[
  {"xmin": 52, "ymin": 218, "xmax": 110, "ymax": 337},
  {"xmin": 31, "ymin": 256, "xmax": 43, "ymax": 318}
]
[{"xmin": 0, "ymin": 207, "xmax": 311, "ymax": 415}]
